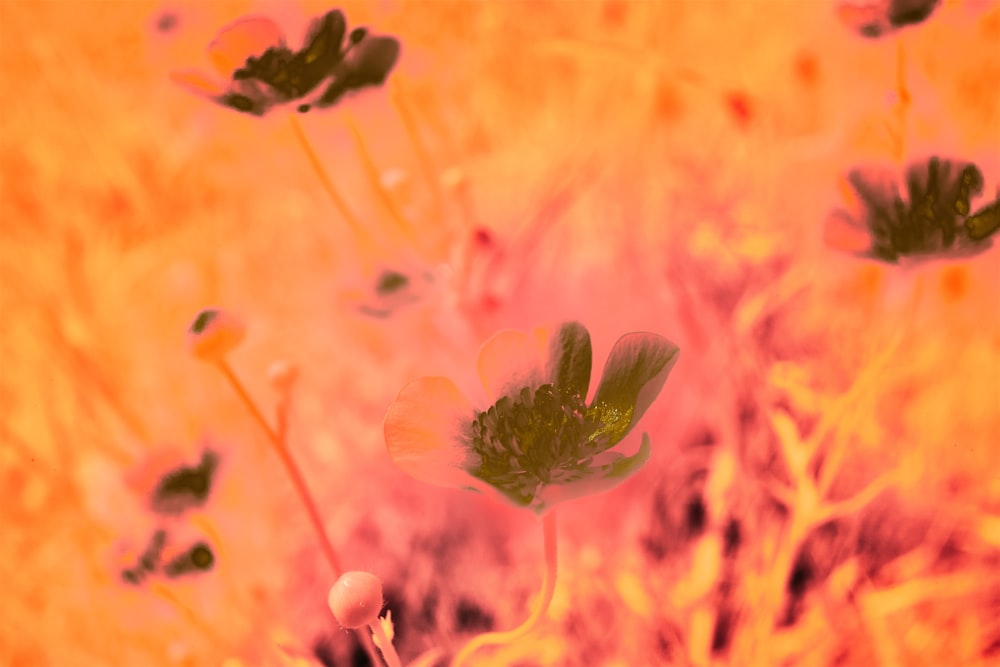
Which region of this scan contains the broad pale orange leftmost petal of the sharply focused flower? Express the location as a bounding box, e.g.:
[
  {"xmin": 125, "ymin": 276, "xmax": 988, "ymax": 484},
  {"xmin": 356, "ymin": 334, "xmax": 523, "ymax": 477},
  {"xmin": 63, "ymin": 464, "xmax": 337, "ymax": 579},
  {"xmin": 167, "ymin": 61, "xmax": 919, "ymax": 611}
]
[{"xmin": 383, "ymin": 377, "xmax": 481, "ymax": 488}]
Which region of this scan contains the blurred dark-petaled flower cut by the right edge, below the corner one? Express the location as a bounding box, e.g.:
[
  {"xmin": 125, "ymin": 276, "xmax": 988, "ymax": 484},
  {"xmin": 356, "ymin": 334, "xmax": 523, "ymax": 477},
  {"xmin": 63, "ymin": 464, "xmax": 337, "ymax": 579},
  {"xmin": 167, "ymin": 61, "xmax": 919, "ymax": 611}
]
[{"xmin": 826, "ymin": 157, "xmax": 1000, "ymax": 264}]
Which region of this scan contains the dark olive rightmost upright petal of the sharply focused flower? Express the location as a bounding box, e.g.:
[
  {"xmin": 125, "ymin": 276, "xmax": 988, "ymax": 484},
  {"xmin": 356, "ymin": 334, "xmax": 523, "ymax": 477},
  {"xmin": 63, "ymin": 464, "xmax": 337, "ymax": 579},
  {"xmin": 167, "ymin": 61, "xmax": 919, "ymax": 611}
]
[{"xmin": 589, "ymin": 333, "xmax": 680, "ymax": 446}]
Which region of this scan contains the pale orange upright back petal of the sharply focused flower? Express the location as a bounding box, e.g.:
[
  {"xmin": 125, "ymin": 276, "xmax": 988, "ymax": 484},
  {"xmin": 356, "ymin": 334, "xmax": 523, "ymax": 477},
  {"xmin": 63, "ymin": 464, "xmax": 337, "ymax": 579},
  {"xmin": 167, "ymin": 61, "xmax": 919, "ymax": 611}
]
[{"xmin": 479, "ymin": 328, "xmax": 549, "ymax": 403}]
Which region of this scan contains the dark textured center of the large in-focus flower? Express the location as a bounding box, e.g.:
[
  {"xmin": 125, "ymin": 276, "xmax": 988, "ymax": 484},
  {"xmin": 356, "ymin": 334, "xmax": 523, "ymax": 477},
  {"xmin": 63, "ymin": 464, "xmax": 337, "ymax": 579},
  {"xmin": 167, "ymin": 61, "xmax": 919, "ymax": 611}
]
[{"xmin": 469, "ymin": 384, "xmax": 613, "ymax": 505}]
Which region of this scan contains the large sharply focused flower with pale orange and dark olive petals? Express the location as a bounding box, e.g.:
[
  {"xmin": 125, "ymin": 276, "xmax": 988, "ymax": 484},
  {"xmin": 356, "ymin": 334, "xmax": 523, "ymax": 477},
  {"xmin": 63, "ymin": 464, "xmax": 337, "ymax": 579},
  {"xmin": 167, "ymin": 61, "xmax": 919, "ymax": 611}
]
[{"xmin": 384, "ymin": 322, "xmax": 679, "ymax": 514}]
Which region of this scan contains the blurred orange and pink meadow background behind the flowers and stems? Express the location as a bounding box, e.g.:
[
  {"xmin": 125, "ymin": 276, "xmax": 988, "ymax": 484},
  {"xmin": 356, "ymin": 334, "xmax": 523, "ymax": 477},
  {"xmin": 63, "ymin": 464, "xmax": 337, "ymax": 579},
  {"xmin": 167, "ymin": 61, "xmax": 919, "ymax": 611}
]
[{"xmin": 0, "ymin": 0, "xmax": 1000, "ymax": 667}]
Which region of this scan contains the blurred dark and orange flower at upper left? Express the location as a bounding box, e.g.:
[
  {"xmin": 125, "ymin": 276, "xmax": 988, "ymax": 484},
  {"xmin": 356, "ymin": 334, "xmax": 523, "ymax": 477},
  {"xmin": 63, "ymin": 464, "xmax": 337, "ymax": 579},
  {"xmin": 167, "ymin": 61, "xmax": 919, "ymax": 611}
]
[{"xmin": 172, "ymin": 10, "xmax": 399, "ymax": 116}]
